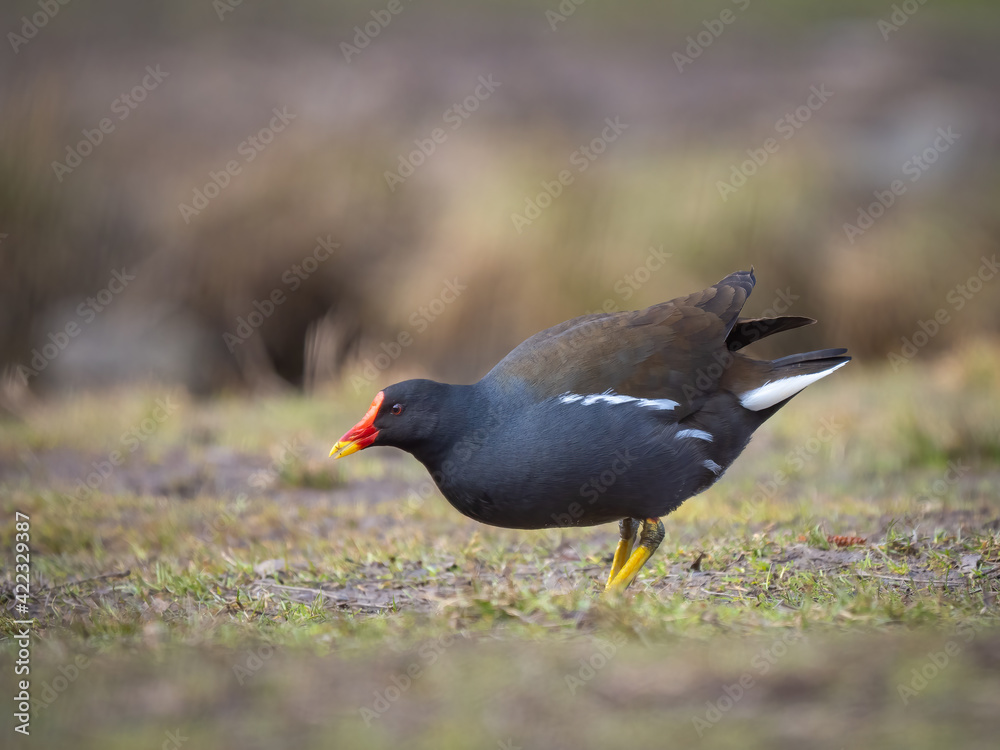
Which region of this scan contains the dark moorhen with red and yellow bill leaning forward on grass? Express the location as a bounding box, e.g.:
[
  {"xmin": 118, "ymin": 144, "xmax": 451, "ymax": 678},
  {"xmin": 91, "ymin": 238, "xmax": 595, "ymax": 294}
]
[{"xmin": 330, "ymin": 269, "xmax": 850, "ymax": 590}]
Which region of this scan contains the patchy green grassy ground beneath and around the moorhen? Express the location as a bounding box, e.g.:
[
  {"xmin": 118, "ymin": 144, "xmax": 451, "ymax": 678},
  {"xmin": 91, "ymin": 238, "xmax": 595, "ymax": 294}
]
[{"xmin": 0, "ymin": 344, "xmax": 1000, "ymax": 748}]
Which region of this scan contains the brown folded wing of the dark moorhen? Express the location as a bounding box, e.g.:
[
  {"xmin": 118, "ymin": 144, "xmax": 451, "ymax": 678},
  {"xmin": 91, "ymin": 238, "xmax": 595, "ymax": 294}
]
[{"xmin": 487, "ymin": 270, "xmax": 755, "ymax": 417}]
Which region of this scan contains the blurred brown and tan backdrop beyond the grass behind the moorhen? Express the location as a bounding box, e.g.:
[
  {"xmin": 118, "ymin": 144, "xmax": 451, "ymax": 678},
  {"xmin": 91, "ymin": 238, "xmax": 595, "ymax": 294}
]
[{"xmin": 0, "ymin": 0, "xmax": 1000, "ymax": 400}]
